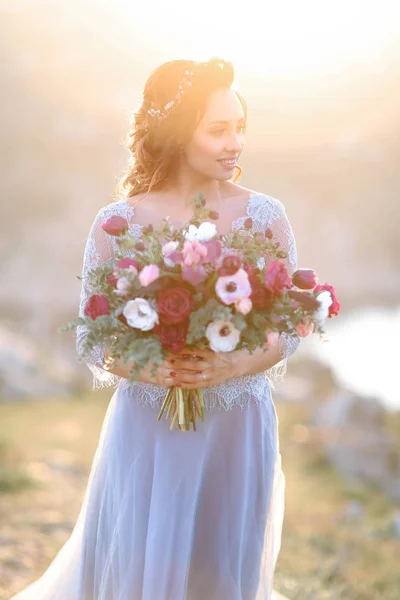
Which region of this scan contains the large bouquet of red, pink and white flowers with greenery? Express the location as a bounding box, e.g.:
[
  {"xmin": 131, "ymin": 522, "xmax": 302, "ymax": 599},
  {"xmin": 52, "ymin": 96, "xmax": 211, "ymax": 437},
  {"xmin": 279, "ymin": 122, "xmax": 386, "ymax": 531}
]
[{"xmin": 61, "ymin": 194, "xmax": 340, "ymax": 431}]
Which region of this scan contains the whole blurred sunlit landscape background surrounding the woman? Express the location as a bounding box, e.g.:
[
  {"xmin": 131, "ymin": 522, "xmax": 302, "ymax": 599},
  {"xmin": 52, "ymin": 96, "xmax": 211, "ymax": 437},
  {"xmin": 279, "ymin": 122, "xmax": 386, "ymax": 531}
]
[{"xmin": 0, "ymin": 0, "xmax": 400, "ymax": 600}]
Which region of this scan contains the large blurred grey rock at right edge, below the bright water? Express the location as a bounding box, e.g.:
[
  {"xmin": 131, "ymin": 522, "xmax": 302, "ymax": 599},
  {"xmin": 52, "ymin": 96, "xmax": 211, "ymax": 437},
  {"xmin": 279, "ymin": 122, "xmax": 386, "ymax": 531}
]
[{"xmin": 313, "ymin": 390, "xmax": 400, "ymax": 500}]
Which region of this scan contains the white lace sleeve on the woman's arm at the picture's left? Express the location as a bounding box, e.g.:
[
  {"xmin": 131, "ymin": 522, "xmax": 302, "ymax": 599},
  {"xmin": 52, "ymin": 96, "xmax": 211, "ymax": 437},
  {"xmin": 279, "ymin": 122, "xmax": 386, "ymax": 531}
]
[{"xmin": 76, "ymin": 207, "xmax": 121, "ymax": 390}]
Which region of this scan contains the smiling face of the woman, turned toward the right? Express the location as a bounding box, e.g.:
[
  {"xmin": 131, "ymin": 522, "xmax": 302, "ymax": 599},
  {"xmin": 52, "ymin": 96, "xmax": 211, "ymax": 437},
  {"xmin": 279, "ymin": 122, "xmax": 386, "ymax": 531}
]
[{"xmin": 185, "ymin": 88, "xmax": 246, "ymax": 181}]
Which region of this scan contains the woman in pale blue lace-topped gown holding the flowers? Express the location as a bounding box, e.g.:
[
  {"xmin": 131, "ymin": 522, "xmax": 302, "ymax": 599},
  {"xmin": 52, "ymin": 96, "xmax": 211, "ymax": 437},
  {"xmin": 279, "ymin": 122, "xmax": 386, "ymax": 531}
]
[{"xmin": 10, "ymin": 59, "xmax": 298, "ymax": 600}]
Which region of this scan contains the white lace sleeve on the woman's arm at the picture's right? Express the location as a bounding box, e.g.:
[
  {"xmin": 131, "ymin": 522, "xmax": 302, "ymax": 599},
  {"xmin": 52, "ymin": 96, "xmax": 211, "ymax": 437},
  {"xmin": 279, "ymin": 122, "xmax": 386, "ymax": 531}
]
[{"xmin": 258, "ymin": 196, "xmax": 300, "ymax": 381}]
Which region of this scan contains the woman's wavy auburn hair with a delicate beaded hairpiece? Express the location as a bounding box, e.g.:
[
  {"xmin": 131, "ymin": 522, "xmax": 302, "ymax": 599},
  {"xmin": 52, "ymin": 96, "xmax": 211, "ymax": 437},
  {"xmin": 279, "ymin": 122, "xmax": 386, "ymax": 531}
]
[{"xmin": 118, "ymin": 58, "xmax": 247, "ymax": 197}]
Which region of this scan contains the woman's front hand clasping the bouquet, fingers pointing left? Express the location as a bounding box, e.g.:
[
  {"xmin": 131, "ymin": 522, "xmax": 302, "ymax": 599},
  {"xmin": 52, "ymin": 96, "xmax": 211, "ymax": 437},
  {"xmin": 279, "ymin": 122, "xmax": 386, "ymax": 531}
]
[{"xmin": 165, "ymin": 348, "xmax": 242, "ymax": 389}]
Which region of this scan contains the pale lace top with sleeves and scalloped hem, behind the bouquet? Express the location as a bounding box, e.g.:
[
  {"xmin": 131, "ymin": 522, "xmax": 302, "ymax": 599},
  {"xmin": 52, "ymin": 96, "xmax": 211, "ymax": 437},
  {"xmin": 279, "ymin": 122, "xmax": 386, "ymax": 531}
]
[{"xmin": 76, "ymin": 192, "xmax": 300, "ymax": 409}]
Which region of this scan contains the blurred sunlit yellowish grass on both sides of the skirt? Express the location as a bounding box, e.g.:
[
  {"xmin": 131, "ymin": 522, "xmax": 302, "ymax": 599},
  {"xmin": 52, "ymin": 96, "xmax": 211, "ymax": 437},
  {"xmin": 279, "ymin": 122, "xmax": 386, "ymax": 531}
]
[{"xmin": 0, "ymin": 391, "xmax": 400, "ymax": 600}]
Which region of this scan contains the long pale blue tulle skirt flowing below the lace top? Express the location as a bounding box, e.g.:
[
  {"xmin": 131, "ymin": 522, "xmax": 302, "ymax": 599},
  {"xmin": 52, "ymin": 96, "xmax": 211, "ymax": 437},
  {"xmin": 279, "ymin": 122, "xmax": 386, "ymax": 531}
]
[{"xmin": 10, "ymin": 387, "xmax": 285, "ymax": 600}]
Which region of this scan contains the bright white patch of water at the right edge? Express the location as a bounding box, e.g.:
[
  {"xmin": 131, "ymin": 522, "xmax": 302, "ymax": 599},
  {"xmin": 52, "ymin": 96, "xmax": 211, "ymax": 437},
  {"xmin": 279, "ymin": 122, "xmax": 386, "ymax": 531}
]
[{"xmin": 300, "ymin": 306, "xmax": 400, "ymax": 410}]
